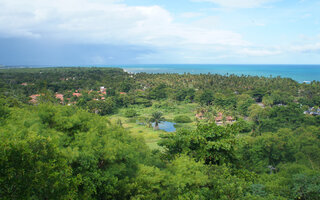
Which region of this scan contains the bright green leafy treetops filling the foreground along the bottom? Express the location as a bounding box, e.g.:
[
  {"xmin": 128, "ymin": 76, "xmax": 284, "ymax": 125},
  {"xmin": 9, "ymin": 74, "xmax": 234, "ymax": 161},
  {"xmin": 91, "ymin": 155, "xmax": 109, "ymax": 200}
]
[{"xmin": 0, "ymin": 104, "xmax": 320, "ymax": 200}]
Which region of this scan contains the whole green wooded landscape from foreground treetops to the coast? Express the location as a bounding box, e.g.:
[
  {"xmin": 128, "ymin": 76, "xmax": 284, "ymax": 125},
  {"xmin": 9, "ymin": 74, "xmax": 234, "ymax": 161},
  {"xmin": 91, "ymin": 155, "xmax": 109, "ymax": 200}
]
[{"xmin": 0, "ymin": 68, "xmax": 320, "ymax": 200}]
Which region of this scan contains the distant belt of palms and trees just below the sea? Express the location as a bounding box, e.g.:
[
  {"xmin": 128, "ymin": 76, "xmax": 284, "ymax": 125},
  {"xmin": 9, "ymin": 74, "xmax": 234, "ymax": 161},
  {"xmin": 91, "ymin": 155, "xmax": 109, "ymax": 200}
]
[{"xmin": 0, "ymin": 68, "xmax": 320, "ymax": 107}]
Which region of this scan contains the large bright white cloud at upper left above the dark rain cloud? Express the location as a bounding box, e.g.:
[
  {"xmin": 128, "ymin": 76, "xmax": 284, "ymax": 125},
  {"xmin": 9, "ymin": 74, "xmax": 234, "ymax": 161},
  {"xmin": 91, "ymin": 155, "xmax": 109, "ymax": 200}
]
[{"xmin": 0, "ymin": 0, "xmax": 247, "ymax": 47}]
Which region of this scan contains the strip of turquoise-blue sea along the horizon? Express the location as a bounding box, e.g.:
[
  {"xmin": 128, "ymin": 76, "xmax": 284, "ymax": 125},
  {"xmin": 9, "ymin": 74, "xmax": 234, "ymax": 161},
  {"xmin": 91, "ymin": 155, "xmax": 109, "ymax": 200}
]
[{"xmin": 113, "ymin": 64, "xmax": 320, "ymax": 82}]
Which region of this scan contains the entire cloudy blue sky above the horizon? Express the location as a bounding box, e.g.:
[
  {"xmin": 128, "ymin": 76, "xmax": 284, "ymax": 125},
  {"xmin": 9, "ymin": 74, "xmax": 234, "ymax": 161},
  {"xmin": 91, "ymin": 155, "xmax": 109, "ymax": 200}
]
[{"xmin": 0, "ymin": 0, "xmax": 320, "ymax": 66}]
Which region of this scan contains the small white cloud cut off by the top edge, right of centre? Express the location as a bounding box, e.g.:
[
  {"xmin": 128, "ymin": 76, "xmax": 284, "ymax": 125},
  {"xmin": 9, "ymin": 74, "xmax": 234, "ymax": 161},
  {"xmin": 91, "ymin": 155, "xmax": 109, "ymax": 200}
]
[{"xmin": 192, "ymin": 0, "xmax": 276, "ymax": 8}]
